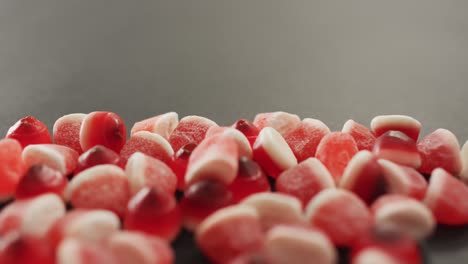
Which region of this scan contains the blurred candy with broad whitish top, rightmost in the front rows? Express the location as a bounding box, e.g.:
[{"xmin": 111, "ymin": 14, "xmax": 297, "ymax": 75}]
[{"xmin": 371, "ymin": 195, "xmax": 436, "ymax": 240}]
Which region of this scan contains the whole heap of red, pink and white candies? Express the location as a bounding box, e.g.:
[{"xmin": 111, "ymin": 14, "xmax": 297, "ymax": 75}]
[{"xmin": 0, "ymin": 112, "xmax": 468, "ymax": 264}]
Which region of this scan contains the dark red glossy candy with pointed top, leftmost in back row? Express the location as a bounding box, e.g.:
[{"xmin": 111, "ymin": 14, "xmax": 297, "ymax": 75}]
[{"xmin": 6, "ymin": 116, "xmax": 52, "ymax": 148}]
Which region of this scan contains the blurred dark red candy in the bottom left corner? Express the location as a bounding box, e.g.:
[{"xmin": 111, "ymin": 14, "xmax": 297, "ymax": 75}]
[{"xmin": 0, "ymin": 232, "xmax": 55, "ymax": 264}]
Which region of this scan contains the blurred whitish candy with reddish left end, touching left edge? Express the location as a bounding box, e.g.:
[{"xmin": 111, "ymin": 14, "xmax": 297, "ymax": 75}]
[{"xmin": 0, "ymin": 194, "xmax": 65, "ymax": 238}]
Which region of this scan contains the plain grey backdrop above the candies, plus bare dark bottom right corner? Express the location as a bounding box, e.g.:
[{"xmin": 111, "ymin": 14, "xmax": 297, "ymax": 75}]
[{"xmin": 0, "ymin": 0, "xmax": 468, "ymax": 263}]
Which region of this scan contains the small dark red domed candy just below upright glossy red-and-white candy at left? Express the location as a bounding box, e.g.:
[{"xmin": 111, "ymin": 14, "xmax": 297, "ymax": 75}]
[{"xmin": 75, "ymin": 145, "xmax": 122, "ymax": 174}]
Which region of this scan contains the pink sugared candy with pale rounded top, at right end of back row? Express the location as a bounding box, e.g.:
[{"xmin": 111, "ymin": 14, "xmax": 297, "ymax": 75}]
[{"xmin": 418, "ymin": 128, "xmax": 462, "ymax": 175}]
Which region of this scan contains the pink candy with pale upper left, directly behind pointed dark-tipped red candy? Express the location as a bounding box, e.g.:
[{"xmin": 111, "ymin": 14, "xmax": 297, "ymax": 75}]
[{"xmin": 125, "ymin": 152, "xmax": 177, "ymax": 194}]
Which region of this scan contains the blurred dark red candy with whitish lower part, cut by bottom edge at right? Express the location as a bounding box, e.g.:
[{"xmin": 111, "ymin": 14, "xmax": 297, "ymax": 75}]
[{"xmin": 351, "ymin": 229, "xmax": 423, "ymax": 264}]
